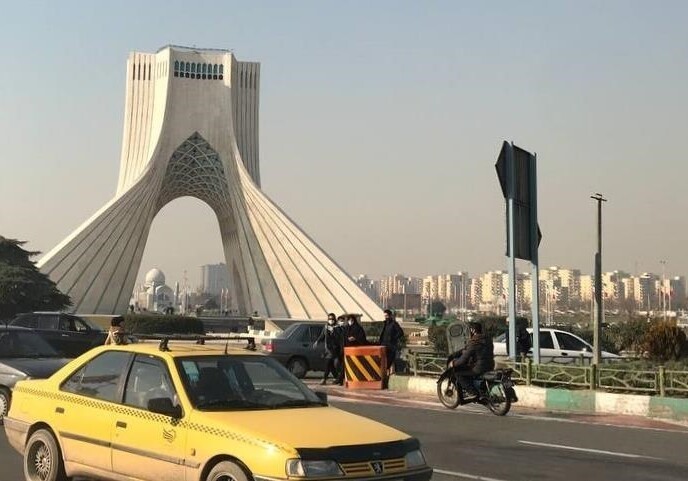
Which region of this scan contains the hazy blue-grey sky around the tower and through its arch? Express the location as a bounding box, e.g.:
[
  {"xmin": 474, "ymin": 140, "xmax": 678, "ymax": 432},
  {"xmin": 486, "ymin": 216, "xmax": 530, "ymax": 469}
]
[{"xmin": 0, "ymin": 0, "xmax": 688, "ymax": 284}]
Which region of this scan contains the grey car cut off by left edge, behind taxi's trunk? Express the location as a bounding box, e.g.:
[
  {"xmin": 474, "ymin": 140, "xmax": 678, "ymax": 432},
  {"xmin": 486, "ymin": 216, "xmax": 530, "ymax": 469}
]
[{"xmin": 0, "ymin": 325, "xmax": 69, "ymax": 423}]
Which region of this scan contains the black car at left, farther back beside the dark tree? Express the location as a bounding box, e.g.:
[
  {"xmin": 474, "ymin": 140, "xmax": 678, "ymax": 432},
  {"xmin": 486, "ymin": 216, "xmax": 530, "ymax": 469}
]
[{"xmin": 10, "ymin": 312, "xmax": 107, "ymax": 358}]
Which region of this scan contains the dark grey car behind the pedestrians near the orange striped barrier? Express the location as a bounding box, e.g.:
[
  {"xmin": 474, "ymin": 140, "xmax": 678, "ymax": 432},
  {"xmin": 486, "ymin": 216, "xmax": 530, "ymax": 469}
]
[{"xmin": 261, "ymin": 322, "xmax": 327, "ymax": 379}]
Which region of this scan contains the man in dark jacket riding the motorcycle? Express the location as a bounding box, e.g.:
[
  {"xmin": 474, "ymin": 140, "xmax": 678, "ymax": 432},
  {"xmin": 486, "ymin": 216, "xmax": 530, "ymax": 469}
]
[{"xmin": 447, "ymin": 322, "xmax": 494, "ymax": 396}]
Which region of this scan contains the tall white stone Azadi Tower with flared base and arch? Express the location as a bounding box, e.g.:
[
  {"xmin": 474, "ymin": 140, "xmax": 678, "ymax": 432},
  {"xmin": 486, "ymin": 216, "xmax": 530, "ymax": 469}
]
[{"xmin": 38, "ymin": 46, "xmax": 383, "ymax": 320}]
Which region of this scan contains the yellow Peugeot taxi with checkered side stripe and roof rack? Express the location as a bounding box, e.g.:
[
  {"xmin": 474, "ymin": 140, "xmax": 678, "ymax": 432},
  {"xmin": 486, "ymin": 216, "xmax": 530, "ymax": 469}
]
[{"xmin": 5, "ymin": 339, "xmax": 432, "ymax": 481}]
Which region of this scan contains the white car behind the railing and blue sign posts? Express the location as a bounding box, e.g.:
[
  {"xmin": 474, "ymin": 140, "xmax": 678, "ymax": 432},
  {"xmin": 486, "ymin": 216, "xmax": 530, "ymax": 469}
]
[{"xmin": 494, "ymin": 328, "xmax": 620, "ymax": 364}]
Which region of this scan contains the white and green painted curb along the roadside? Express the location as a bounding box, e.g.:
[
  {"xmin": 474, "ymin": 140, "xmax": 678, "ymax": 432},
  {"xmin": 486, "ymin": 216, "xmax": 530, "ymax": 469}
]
[{"xmin": 389, "ymin": 375, "xmax": 688, "ymax": 423}]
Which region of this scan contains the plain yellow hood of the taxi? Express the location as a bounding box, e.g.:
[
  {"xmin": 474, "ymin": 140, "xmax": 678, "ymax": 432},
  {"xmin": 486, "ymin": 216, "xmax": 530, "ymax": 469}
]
[{"xmin": 198, "ymin": 406, "xmax": 410, "ymax": 452}]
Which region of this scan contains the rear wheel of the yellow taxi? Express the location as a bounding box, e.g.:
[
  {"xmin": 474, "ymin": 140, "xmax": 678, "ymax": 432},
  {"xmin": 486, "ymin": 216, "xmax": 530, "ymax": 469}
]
[{"xmin": 24, "ymin": 429, "xmax": 68, "ymax": 481}]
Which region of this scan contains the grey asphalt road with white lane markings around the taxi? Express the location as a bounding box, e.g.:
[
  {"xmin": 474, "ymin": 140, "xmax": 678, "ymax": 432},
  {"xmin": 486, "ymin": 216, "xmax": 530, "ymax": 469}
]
[{"xmin": 0, "ymin": 397, "xmax": 688, "ymax": 481}]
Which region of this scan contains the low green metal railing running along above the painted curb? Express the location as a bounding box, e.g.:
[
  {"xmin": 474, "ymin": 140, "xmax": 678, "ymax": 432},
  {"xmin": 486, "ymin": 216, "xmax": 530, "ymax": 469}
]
[{"xmin": 407, "ymin": 352, "xmax": 688, "ymax": 397}]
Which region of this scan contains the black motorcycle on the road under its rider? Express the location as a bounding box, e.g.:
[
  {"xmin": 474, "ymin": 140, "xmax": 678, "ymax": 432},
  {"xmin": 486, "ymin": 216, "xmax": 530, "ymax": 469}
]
[{"xmin": 437, "ymin": 366, "xmax": 518, "ymax": 416}]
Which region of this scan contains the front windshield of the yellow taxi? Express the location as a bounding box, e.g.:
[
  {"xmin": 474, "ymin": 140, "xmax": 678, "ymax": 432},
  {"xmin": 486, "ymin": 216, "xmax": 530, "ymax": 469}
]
[{"xmin": 176, "ymin": 355, "xmax": 326, "ymax": 411}]
